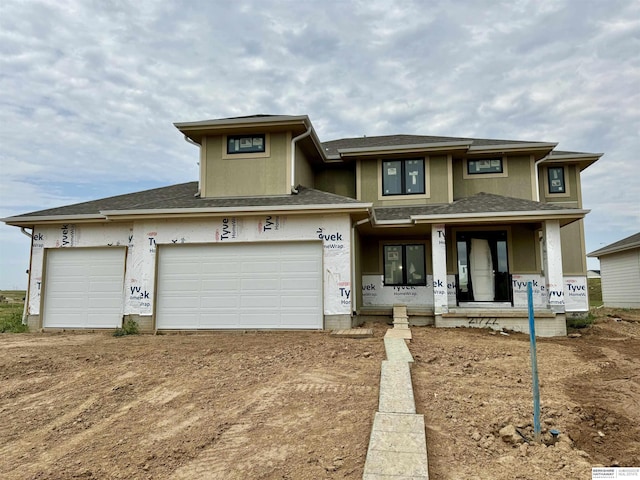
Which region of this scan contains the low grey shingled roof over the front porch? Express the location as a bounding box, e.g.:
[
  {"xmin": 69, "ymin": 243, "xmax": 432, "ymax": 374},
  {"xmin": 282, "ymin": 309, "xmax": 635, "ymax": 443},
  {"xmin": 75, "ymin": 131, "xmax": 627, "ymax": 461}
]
[{"xmin": 374, "ymin": 192, "xmax": 588, "ymax": 225}]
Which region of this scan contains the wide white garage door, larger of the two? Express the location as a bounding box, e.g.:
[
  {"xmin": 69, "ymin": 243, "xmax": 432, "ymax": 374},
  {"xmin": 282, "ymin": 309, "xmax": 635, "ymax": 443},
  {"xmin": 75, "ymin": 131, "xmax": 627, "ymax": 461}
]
[{"xmin": 156, "ymin": 242, "xmax": 322, "ymax": 329}]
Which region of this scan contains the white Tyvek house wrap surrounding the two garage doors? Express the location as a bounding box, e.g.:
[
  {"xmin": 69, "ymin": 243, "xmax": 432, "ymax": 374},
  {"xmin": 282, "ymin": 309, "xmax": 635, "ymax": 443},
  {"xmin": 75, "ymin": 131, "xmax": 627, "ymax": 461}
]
[{"xmin": 29, "ymin": 214, "xmax": 352, "ymax": 316}]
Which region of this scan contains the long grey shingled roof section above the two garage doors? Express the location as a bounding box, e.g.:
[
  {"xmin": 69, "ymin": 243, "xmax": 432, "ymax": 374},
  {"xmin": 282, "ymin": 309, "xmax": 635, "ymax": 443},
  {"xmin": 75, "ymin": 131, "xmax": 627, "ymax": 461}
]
[{"xmin": 3, "ymin": 182, "xmax": 371, "ymax": 226}]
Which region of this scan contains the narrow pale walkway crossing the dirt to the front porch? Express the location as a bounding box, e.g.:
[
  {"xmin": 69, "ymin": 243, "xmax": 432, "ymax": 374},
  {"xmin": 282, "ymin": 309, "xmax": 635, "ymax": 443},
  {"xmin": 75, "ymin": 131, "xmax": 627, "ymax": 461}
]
[{"xmin": 362, "ymin": 308, "xmax": 429, "ymax": 480}]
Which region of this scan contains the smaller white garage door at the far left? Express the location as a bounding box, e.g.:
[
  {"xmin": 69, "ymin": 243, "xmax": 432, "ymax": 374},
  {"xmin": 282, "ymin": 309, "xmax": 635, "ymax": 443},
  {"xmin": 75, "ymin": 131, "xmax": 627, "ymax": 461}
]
[{"xmin": 43, "ymin": 248, "xmax": 125, "ymax": 328}]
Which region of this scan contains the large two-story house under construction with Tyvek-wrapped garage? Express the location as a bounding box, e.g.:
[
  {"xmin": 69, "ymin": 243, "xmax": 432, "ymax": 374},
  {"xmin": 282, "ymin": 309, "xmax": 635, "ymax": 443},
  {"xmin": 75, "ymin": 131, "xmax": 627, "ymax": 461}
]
[{"xmin": 4, "ymin": 115, "xmax": 601, "ymax": 336}]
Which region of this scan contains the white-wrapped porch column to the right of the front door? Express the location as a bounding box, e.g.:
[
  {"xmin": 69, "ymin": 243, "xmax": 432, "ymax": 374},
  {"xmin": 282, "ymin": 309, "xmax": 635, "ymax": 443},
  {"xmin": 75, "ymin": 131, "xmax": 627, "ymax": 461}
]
[{"xmin": 543, "ymin": 220, "xmax": 564, "ymax": 313}]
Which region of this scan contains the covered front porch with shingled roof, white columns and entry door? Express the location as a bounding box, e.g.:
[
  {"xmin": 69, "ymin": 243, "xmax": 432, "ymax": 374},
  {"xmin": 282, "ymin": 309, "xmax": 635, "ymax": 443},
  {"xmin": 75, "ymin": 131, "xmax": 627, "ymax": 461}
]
[{"xmin": 354, "ymin": 194, "xmax": 586, "ymax": 336}]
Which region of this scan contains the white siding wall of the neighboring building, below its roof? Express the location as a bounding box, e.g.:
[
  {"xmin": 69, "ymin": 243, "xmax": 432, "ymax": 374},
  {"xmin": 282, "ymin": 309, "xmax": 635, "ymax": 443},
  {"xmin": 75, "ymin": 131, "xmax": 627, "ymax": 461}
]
[{"xmin": 600, "ymin": 248, "xmax": 640, "ymax": 308}]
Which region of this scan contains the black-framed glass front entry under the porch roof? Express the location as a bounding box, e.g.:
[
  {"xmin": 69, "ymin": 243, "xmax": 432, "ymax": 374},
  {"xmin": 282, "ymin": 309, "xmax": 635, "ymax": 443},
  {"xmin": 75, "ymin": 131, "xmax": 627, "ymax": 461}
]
[{"xmin": 456, "ymin": 231, "xmax": 511, "ymax": 302}]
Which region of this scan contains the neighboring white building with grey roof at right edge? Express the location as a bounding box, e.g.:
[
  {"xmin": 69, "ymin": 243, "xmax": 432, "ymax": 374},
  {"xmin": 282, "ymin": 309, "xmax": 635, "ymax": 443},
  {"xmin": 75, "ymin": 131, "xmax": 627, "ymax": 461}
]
[{"xmin": 588, "ymin": 233, "xmax": 640, "ymax": 308}]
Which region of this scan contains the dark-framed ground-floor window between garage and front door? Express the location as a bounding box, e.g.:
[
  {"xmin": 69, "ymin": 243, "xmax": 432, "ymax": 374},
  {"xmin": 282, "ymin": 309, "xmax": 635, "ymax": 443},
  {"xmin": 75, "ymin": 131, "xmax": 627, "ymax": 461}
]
[{"xmin": 383, "ymin": 245, "xmax": 427, "ymax": 285}]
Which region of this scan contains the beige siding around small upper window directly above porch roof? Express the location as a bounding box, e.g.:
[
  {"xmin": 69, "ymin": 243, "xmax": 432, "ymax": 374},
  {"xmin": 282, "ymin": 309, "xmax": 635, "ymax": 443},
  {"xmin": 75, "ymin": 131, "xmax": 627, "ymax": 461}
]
[{"xmin": 453, "ymin": 155, "xmax": 532, "ymax": 200}]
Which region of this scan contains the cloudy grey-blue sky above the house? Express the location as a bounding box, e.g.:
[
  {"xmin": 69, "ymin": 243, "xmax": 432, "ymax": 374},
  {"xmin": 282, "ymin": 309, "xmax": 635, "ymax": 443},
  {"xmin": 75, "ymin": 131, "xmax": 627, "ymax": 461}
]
[{"xmin": 0, "ymin": 0, "xmax": 640, "ymax": 288}]
